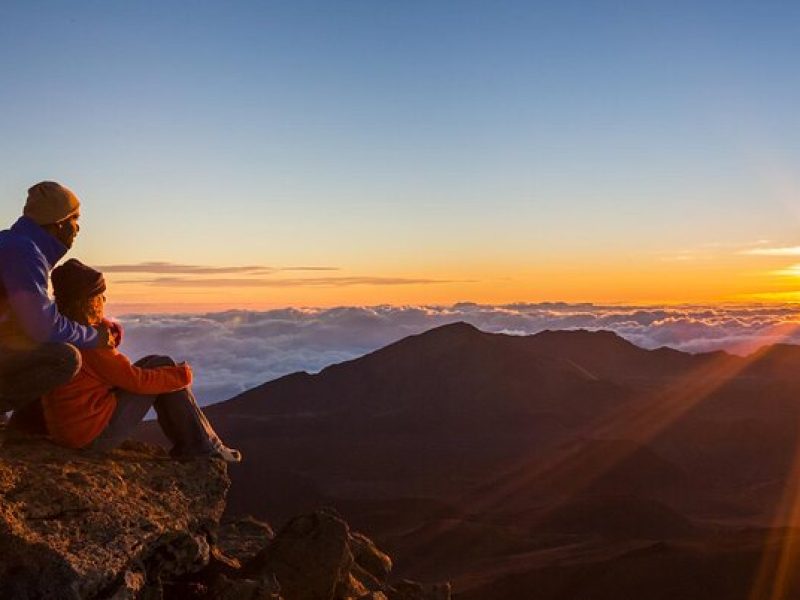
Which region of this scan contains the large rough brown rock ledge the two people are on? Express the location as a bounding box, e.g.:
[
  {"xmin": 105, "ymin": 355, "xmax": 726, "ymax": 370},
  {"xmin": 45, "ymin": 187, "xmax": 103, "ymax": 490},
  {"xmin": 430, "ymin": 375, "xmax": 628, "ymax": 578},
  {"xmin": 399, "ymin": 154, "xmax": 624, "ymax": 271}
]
[{"xmin": 0, "ymin": 440, "xmax": 229, "ymax": 600}]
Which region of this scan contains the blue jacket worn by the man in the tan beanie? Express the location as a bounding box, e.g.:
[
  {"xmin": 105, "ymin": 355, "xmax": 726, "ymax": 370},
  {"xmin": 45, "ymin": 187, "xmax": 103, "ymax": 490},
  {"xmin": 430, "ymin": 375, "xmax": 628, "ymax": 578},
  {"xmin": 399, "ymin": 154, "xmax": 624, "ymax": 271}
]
[{"xmin": 0, "ymin": 217, "xmax": 98, "ymax": 350}]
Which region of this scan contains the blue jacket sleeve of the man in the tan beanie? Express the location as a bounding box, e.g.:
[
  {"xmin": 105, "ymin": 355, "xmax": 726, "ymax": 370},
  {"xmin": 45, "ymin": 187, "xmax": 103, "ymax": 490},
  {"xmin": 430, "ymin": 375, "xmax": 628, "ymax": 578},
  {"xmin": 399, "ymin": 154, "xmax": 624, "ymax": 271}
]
[{"xmin": 0, "ymin": 241, "xmax": 98, "ymax": 348}]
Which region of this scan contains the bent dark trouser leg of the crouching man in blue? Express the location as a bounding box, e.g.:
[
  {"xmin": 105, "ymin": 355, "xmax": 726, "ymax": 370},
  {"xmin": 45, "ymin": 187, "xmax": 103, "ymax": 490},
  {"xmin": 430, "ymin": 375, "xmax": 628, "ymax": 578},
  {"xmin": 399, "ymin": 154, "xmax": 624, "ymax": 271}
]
[{"xmin": 0, "ymin": 344, "xmax": 81, "ymax": 412}]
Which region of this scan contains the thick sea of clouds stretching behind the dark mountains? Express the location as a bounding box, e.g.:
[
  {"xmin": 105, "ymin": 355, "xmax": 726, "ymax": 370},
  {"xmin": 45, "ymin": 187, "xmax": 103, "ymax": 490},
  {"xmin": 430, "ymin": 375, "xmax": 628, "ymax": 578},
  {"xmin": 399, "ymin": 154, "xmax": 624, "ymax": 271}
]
[{"xmin": 114, "ymin": 303, "xmax": 800, "ymax": 404}]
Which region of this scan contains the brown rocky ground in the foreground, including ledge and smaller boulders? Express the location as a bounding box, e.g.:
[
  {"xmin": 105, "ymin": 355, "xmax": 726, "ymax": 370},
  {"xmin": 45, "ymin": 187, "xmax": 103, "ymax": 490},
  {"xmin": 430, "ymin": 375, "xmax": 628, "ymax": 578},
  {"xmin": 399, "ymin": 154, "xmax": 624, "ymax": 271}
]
[{"xmin": 0, "ymin": 428, "xmax": 450, "ymax": 600}]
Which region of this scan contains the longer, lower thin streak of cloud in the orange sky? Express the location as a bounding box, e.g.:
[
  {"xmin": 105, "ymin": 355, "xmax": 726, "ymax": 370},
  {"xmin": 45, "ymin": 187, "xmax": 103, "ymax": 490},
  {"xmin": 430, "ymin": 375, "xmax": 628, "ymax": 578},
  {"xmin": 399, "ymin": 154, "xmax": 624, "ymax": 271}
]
[{"xmin": 116, "ymin": 276, "xmax": 455, "ymax": 288}]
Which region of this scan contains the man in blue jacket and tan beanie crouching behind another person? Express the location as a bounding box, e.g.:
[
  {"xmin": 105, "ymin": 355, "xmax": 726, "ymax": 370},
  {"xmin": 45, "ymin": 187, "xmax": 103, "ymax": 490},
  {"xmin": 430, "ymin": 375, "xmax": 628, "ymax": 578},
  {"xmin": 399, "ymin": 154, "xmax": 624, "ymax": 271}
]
[{"xmin": 0, "ymin": 181, "xmax": 113, "ymax": 428}]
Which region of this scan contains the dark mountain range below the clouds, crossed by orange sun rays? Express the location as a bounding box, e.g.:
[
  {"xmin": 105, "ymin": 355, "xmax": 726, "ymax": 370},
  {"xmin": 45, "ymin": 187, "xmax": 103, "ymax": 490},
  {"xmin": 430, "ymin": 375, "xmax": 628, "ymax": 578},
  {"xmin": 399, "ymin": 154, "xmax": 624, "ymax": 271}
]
[{"xmin": 144, "ymin": 323, "xmax": 800, "ymax": 600}]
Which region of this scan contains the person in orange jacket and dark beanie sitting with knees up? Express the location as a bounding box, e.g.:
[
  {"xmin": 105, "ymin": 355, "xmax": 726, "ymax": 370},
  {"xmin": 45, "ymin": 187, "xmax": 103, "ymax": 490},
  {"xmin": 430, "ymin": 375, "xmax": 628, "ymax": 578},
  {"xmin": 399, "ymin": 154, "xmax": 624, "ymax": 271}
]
[{"xmin": 42, "ymin": 259, "xmax": 241, "ymax": 462}]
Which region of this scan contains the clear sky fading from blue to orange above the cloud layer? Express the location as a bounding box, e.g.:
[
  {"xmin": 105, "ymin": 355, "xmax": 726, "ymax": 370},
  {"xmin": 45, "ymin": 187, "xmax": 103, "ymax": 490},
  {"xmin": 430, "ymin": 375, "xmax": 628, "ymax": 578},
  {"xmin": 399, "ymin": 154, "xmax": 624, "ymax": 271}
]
[{"xmin": 0, "ymin": 0, "xmax": 800, "ymax": 314}]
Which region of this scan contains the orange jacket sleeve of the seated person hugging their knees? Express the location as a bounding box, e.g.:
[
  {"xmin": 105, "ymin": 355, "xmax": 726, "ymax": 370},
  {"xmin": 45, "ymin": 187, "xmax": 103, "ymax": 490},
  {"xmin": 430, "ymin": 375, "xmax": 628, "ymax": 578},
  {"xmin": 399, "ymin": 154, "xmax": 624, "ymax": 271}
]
[{"xmin": 82, "ymin": 349, "xmax": 192, "ymax": 394}]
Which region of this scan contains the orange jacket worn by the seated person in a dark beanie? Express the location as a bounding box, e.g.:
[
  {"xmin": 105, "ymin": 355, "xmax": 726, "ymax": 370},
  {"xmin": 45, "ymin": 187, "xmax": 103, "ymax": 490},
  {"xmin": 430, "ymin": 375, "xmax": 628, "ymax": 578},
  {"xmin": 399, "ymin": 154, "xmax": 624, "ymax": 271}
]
[{"xmin": 42, "ymin": 348, "xmax": 192, "ymax": 448}]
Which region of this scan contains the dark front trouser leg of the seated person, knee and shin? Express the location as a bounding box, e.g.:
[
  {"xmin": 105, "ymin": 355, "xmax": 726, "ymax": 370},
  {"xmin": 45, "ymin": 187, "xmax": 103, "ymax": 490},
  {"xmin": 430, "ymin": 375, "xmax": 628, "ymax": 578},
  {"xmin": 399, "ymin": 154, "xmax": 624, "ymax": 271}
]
[{"xmin": 136, "ymin": 356, "xmax": 220, "ymax": 456}]
